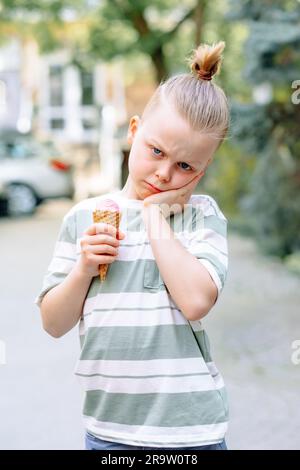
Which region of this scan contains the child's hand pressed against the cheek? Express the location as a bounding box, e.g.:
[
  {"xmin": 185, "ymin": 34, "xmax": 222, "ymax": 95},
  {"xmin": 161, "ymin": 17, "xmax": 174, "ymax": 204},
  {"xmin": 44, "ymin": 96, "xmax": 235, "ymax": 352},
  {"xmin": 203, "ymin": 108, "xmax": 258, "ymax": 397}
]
[{"xmin": 143, "ymin": 171, "xmax": 204, "ymax": 217}]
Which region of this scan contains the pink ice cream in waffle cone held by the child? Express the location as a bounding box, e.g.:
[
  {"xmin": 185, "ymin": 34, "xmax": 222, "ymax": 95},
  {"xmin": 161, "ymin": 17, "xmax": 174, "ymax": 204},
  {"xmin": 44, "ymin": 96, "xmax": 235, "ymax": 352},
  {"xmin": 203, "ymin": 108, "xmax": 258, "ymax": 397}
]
[{"xmin": 93, "ymin": 199, "xmax": 122, "ymax": 282}]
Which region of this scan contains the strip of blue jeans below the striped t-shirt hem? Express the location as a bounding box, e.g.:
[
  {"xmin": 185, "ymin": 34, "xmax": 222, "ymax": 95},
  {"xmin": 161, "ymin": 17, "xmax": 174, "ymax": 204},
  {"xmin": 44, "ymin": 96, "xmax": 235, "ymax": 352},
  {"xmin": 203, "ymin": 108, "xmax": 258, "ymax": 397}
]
[{"xmin": 85, "ymin": 432, "xmax": 227, "ymax": 450}]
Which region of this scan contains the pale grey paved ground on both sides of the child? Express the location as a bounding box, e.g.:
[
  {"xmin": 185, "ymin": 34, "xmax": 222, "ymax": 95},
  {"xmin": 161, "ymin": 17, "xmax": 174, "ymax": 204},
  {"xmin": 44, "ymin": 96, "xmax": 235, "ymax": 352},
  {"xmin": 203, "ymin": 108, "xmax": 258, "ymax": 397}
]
[{"xmin": 0, "ymin": 201, "xmax": 300, "ymax": 449}]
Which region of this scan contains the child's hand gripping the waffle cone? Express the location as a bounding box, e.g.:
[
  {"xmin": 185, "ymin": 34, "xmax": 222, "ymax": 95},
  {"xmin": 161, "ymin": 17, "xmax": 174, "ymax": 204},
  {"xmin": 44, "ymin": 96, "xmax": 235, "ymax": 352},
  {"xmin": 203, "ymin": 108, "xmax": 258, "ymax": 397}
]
[{"xmin": 77, "ymin": 223, "xmax": 125, "ymax": 277}]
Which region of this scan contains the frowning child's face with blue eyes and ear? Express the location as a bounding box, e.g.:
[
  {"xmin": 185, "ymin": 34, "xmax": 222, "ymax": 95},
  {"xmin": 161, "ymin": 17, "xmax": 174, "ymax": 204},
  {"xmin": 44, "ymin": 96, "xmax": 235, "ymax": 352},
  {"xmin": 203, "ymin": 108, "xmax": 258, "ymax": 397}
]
[{"xmin": 126, "ymin": 104, "xmax": 219, "ymax": 199}]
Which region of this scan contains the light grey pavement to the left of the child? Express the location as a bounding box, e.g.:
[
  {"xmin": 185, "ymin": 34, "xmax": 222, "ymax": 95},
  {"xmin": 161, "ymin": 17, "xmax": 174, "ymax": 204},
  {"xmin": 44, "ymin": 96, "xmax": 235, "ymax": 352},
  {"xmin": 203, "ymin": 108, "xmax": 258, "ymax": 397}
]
[{"xmin": 0, "ymin": 202, "xmax": 83, "ymax": 449}]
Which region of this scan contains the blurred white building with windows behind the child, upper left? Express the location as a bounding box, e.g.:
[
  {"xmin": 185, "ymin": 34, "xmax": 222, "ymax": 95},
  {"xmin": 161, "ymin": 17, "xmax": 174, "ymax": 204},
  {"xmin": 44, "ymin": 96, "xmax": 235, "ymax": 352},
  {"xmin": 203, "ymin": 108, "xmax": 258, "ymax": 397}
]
[{"xmin": 0, "ymin": 36, "xmax": 126, "ymax": 195}]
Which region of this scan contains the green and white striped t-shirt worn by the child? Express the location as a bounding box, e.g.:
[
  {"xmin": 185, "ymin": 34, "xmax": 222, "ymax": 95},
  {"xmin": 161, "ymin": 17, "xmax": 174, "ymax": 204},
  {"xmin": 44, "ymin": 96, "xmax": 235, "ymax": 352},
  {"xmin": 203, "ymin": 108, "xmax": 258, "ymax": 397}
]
[{"xmin": 36, "ymin": 191, "xmax": 228, "ymax": 448}]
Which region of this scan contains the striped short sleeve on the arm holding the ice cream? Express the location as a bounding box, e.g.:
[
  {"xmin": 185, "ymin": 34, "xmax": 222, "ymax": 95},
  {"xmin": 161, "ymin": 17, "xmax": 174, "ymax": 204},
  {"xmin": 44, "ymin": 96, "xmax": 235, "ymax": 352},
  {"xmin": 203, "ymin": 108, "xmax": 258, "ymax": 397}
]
[{"xmin": 34, "ymin": 211, "xmax": 76, "ymax": 307}]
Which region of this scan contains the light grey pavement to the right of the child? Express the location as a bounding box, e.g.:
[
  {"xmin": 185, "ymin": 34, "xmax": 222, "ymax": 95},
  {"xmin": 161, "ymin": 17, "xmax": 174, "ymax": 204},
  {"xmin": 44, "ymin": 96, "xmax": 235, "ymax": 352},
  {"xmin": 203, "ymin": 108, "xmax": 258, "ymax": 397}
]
[{"xmin": 204, "ymin": 234, "xmax": 300, "ymax": 449}]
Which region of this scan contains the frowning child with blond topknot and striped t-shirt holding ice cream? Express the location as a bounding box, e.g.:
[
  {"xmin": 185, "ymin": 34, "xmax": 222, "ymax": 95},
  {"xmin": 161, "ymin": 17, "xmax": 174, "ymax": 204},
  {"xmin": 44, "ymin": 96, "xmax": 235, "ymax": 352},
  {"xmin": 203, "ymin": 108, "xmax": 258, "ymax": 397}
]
[{"xmin": 36, "ymin": 42, "xmax": 229, "ymax": 450}]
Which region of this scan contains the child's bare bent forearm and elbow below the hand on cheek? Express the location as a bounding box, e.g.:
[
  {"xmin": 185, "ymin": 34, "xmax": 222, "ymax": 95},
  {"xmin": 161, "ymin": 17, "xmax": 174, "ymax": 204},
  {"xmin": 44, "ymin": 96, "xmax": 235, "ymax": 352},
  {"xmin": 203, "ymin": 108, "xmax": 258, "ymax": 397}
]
[{"xmin": 143, "ymin": 204, "xmax": 218, "ymax": 321}]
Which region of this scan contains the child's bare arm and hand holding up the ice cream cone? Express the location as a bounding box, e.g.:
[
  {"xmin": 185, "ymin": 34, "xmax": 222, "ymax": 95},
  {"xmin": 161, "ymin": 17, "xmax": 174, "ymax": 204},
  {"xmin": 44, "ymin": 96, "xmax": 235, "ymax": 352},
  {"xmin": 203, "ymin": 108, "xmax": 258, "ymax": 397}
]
[{"xmin": 40, "ymin": 223, "xmax": 124, "ymax": 338}]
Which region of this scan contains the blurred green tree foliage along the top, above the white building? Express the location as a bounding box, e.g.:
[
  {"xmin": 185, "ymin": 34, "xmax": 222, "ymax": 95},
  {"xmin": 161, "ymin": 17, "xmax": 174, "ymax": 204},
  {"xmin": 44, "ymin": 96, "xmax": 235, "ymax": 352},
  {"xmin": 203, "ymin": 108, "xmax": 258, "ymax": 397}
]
[{"xmin": 0, "ymin": 0, "xmax": 213, "ymax": 82}]
